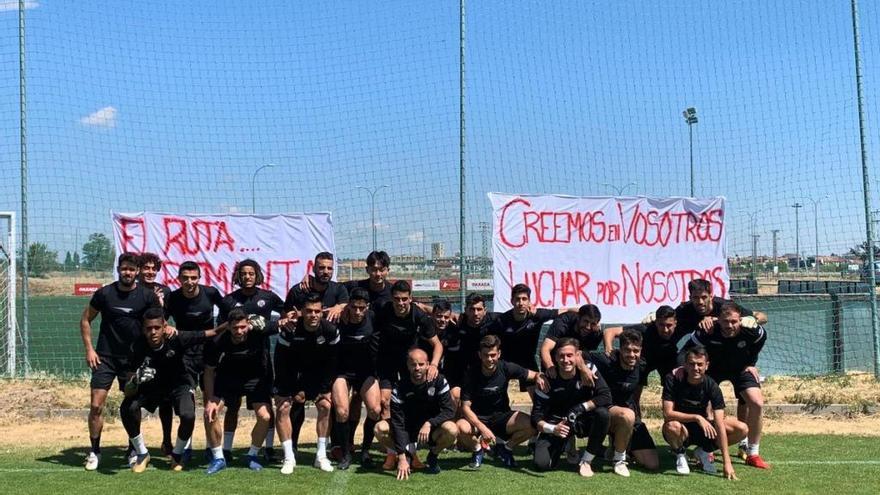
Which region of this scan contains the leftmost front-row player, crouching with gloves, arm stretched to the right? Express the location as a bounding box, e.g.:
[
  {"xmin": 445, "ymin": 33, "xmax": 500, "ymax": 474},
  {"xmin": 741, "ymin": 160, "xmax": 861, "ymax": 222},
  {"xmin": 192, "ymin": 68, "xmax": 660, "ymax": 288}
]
[{"xmin": 119, "ymin": 308, "xmax": 223, "ymax": 473}]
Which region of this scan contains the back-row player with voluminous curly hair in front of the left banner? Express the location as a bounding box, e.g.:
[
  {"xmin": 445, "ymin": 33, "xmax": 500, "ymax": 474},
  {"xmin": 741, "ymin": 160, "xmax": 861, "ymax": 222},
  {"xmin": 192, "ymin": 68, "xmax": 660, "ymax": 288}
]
[{"xmin": 217, "ymin": 259, "xmax": 287, "ymax": 462}]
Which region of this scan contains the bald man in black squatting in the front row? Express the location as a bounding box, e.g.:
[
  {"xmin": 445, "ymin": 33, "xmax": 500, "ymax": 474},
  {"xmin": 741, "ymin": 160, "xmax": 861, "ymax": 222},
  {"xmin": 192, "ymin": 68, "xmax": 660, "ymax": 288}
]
[{"xmin": 376, "ymin": 348, "xmax": 458, "ymax": 480}]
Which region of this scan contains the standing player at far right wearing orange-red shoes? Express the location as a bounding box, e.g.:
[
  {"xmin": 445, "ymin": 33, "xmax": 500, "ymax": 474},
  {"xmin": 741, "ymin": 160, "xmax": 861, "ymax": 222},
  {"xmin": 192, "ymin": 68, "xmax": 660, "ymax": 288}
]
[{"xmin": 685, "ymin": 302, "xmax": 770, "ymax": 469}]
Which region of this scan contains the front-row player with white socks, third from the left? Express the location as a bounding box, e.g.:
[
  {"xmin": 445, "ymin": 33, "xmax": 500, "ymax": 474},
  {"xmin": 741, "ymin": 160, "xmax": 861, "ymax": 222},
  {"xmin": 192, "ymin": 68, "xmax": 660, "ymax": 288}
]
[{"xmin": 275, "ymin": 293, "xmax": 339, "ymax": 474}]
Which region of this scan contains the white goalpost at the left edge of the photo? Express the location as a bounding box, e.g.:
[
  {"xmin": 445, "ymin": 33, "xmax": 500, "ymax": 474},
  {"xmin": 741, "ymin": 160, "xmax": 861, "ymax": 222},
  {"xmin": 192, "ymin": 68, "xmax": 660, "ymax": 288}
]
[{"xmin": 0, "ymin": 211, "xmax": 17, "ymax": 377}]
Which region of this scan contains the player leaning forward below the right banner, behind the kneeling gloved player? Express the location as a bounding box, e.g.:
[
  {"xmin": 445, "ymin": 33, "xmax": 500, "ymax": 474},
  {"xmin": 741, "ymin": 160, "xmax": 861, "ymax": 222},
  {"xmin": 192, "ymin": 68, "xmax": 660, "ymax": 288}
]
[{"xmin": 541, "ymin": 304, "xmax": 602, "ymax": 378}]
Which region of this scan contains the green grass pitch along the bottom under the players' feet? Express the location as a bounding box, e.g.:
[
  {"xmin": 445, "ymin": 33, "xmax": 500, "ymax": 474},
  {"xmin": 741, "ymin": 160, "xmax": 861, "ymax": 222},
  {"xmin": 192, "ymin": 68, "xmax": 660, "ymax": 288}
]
[{"xmin": 0, "ymin": 435, "xmax": 880, "ymax": 495}]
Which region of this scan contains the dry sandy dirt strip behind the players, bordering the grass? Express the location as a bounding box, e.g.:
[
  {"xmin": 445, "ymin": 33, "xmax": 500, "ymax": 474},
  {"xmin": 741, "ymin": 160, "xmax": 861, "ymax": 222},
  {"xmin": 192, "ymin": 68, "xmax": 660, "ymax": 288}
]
[{"xmin": 0, "ymin": 374, "xmax": 880, "ymax": 450}]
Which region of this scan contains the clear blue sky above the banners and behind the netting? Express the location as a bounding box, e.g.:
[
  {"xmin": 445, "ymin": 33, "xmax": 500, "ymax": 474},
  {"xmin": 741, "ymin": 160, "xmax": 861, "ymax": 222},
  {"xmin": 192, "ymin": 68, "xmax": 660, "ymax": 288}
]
[{"xmin": 0, "ymin": 0, "xmax": 880, "ymax": 262}]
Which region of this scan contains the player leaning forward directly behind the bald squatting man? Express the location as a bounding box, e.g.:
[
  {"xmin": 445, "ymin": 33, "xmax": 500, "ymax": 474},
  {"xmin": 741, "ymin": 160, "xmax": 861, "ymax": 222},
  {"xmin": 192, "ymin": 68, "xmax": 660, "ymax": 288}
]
[{"xmin": 375, "ymin": 280, "xmax": 443, "ymax": 470}]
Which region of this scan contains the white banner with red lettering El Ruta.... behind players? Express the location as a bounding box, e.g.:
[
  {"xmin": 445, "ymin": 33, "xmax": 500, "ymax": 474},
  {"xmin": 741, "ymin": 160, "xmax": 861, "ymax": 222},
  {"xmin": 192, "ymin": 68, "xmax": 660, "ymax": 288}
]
[{"xmin": 111, "ymin": 212, "xmax": 335, "ymax": 298}]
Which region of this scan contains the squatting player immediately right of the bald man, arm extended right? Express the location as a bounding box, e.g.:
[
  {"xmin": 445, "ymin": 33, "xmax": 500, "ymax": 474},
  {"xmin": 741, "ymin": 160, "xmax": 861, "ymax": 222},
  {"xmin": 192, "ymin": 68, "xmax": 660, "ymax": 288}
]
[{"xmin": 457, "ymin": 335, "xmax": 547, "ymax": 469}]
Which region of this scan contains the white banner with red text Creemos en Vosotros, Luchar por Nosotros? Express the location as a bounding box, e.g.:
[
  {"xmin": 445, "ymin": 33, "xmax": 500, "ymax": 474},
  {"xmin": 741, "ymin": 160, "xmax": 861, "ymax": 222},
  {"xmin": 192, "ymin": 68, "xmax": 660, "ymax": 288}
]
[{"xmin": 489, "ymin": 193, "xmax": 730, "ymax": 323}]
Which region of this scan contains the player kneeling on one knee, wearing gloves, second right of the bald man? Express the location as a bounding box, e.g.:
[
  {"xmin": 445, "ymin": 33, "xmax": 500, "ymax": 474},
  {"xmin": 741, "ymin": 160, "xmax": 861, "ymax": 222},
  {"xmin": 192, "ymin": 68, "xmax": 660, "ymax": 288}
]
[{"xmin": 532, "ymin": 338, "xmax": 611, "ymax": 478}]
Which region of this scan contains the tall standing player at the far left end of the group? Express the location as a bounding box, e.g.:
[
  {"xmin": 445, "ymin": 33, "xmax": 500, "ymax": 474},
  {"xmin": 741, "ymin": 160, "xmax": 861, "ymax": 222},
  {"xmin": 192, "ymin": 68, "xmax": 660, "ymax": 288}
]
[{"xmin": 79, "ymin": 253, "xmax": 160, "ymax": 471}]
